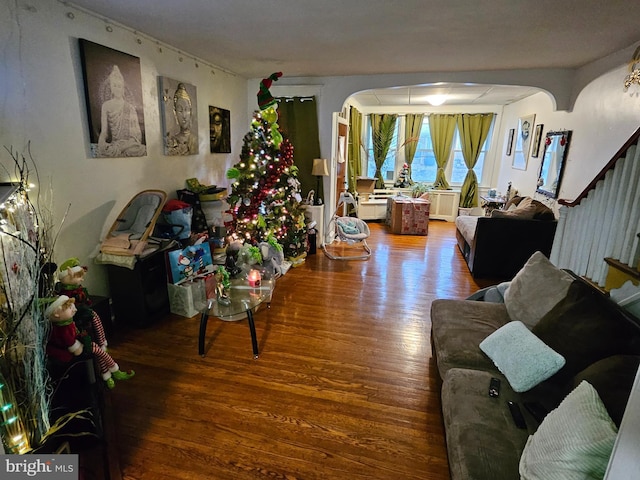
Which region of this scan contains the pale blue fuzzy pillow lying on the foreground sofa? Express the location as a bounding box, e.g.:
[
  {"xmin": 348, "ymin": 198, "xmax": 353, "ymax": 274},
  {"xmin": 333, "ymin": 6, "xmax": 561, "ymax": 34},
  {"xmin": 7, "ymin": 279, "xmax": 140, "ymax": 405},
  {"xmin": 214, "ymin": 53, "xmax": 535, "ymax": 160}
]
[{"xmin": 480, "ymin": 321, "xmax": 565, "ymax": 392}]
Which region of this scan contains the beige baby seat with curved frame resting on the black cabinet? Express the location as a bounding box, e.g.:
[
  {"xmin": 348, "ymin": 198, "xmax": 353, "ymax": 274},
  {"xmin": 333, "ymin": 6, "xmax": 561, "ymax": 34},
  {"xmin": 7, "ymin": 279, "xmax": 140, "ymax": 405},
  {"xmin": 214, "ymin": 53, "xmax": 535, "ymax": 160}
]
[{"xmin": 100, "ymin": 190, "xmax": 167, "ymax": 256}]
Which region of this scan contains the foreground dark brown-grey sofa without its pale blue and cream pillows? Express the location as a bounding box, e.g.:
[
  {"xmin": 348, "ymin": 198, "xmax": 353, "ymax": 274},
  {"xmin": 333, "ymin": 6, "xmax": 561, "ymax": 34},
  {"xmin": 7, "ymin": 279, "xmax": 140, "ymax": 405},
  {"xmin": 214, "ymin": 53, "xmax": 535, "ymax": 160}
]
[{"xmin": 431, "ymin": 252, "xmax": 640, "ymax": 480}]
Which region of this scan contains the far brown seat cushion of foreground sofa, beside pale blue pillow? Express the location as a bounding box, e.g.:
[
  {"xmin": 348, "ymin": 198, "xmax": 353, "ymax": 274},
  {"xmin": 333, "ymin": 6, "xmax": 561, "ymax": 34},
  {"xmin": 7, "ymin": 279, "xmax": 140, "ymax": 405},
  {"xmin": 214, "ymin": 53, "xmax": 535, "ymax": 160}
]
[{"xmin": 431, "ymin": 299, "xmax": 510, "ymax": 379}]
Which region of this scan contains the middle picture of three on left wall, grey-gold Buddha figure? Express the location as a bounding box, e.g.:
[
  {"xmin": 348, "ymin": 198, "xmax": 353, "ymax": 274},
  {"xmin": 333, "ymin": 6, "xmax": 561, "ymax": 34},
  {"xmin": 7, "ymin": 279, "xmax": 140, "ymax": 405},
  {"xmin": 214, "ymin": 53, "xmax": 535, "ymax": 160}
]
[{"xmin": 159, "ymin": 77, "xmax": 199, "ymax": 156}]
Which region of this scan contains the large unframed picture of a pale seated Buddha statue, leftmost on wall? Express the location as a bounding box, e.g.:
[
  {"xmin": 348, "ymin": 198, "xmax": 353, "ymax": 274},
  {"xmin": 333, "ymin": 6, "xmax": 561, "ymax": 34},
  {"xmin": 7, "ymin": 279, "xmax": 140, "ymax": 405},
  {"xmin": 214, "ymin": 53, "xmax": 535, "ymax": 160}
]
[{"xmin": 80, "ymin": 39, "xmax": 147, "ymax": 157}]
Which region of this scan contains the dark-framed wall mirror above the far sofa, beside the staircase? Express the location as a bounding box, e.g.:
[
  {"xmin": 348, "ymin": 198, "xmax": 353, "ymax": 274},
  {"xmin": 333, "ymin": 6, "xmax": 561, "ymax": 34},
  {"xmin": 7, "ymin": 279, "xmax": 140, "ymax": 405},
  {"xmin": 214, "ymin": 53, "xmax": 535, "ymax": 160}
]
[{"xmin": 536, "ymin": 130, "xmax": 571, "ymax": 198}]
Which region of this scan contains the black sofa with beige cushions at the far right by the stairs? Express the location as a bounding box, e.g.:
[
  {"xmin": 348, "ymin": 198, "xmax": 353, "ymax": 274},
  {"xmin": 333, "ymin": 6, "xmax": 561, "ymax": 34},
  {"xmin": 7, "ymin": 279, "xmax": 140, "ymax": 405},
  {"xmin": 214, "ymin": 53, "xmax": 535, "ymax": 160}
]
[{"xmin": 455, "ymin": 197, "xmax": 557, "ymax": 279}]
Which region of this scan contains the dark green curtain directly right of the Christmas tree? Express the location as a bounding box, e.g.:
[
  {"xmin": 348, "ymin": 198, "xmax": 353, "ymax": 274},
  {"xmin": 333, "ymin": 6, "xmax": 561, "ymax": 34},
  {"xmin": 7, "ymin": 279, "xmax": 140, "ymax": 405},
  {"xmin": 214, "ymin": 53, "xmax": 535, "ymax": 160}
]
[{"xmin": 277, "ymin": 96, "xmax": 324, "ymax": 198}]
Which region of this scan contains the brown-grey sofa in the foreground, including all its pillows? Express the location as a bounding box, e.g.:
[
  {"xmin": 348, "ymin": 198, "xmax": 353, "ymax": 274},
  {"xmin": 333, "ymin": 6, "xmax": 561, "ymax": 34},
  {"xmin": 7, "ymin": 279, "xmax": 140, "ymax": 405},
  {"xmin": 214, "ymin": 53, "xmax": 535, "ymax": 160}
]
[{"xmin": 431, "ymin": 252, "xmax": 640, "ymax": 480}]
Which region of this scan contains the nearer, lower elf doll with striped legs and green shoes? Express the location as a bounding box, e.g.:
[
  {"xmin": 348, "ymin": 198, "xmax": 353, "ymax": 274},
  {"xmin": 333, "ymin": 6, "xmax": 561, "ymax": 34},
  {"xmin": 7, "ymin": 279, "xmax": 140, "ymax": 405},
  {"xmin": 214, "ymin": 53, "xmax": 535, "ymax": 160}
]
[{"xmin": 44, "ymin": 295, "xmax": 135, "ymax": 388}]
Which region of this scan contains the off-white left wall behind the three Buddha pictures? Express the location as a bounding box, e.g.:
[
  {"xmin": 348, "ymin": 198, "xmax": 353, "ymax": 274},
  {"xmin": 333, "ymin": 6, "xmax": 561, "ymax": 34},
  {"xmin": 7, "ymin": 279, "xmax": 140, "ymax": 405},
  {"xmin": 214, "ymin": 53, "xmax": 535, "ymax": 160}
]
[{"xmin": 0, "ymin": 0, "xmax": 249, "ymax": 295}]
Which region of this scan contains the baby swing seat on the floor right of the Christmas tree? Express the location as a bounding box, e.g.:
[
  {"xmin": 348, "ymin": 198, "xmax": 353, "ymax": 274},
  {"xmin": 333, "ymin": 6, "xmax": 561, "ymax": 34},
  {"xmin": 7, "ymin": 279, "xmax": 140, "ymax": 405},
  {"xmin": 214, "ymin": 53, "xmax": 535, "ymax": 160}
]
[{"xmin": 322, "ymin": 191, "xmax": 371, "ymax": 260}]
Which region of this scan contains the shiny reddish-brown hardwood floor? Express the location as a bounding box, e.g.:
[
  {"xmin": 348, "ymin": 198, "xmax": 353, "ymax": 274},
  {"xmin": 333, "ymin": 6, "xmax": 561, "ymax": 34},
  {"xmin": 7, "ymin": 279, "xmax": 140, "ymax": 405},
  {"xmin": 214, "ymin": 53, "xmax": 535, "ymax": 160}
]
[{"xmin": 108, "ymin": 221, "xmax": 492, "ymax": 480}]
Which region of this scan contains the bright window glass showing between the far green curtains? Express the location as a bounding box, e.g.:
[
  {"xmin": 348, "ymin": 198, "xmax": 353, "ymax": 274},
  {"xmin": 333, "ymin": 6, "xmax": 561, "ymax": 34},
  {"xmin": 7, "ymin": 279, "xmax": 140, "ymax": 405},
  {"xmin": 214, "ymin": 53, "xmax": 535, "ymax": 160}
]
[{"xmin": 366, "ymin": 116, "xmax": 493, "ymax": 186}]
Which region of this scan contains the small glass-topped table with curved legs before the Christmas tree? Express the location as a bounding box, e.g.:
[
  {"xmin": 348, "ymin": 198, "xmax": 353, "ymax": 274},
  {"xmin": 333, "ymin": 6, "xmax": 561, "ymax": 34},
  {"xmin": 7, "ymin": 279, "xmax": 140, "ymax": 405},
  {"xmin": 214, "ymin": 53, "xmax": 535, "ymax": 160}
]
[{"xmin": 198, "ymin": 278, "xmax": 276, "ymax": 359}]
